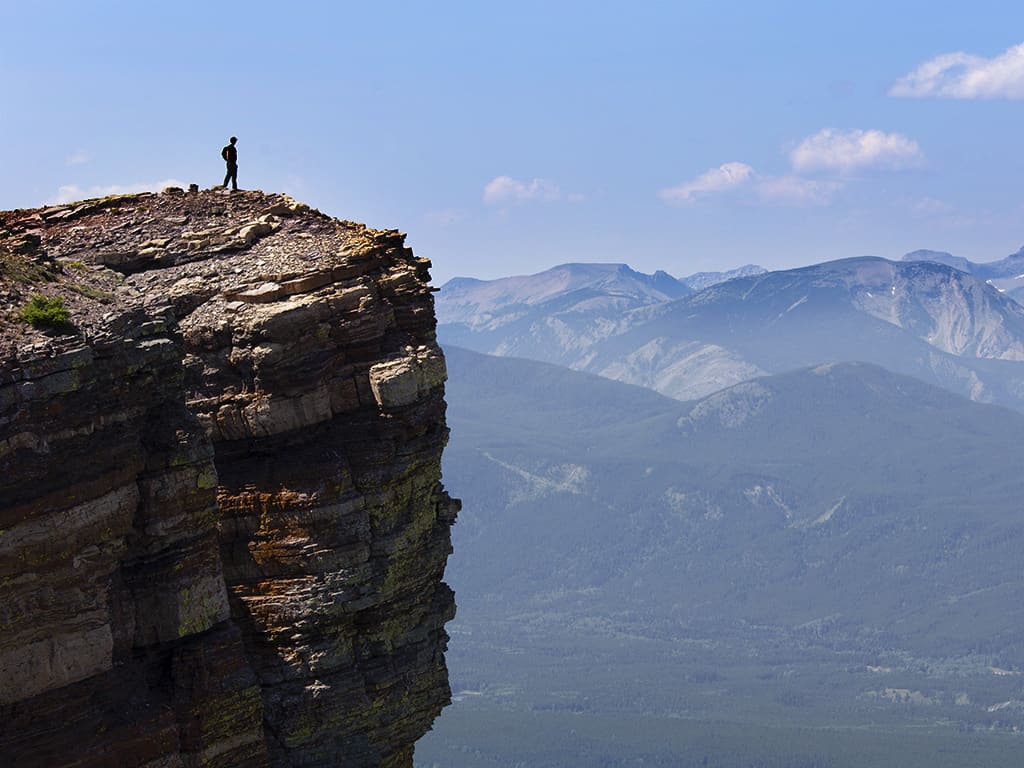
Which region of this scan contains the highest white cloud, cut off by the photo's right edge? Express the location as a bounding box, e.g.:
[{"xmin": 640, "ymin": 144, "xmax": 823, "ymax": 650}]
[{"xmin": 889, "ymin": 44, "xmax": 1024, "ymax": 98}]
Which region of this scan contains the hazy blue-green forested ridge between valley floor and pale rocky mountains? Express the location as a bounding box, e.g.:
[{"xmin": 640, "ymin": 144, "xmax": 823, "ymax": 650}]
[{"xmin": 445, "ymin": 347, "xmax": 1024, "ymax": 651}]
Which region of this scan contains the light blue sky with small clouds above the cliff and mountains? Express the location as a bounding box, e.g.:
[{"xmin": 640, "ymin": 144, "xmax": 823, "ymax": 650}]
[{"xmin": 0, "ymin": 0, "xmax": 1024, "ymax": 283}]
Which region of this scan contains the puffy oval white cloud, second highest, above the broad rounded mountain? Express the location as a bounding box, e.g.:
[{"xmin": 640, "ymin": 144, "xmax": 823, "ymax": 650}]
[{"xmin": 790, "ymin": 128, "xmax": 925, "ymax": 173}]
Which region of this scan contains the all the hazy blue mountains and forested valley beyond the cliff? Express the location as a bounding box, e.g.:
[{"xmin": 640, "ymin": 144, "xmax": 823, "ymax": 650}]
[{"xmin": 418, "ymin": 254, "xmax": 1024, "ymax": 768}]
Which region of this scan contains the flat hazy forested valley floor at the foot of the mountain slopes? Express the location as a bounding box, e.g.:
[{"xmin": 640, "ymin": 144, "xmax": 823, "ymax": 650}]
[{"xmin": 416, "ymin": 616, "xmax": 1024, "ymax": 768}]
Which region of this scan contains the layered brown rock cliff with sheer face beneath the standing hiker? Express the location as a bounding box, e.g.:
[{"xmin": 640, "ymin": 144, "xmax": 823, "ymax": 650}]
[{"xmin": 0, "ymin": 189, "xmax": 458, "ymax": 768}]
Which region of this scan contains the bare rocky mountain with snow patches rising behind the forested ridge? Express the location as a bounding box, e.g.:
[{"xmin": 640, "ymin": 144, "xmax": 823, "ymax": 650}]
[{"xmin": 438, "ymin": 257, "xmax": 1024, "ymax": 409}]
